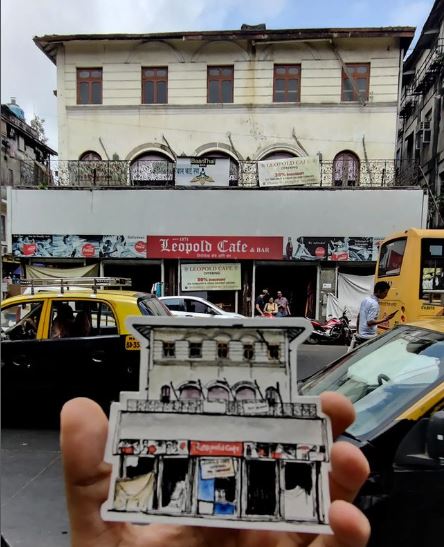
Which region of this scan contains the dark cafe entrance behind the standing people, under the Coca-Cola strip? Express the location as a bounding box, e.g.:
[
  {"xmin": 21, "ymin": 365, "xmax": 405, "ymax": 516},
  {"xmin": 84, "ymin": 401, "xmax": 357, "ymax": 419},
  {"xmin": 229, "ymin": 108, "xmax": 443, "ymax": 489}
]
[{"xmin": 254, "ymin": 263, "xmax": 318, "ymax": 317}]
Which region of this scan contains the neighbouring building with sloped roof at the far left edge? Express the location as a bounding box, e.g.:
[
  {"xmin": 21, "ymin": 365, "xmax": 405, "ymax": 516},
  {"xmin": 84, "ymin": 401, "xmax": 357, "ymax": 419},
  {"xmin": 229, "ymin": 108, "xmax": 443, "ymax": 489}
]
[{"xmin": 0, "ymin": 97, "xmax": 57, "ymax": 276}]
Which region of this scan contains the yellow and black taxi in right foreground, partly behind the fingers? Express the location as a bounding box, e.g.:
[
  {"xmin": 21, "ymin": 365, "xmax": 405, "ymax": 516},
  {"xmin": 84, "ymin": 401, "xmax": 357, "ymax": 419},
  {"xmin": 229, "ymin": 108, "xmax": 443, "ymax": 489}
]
[{"xmin": 300, "ymin": 318, "xmax": 444, "ymax": 547}]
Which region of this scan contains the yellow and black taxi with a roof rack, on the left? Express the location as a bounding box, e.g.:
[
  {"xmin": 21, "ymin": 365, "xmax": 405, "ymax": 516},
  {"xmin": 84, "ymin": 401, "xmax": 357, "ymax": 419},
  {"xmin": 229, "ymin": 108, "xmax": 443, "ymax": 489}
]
[{"xmin": 1, "ymin": 278, "xmax": 171, "ymax": 423}]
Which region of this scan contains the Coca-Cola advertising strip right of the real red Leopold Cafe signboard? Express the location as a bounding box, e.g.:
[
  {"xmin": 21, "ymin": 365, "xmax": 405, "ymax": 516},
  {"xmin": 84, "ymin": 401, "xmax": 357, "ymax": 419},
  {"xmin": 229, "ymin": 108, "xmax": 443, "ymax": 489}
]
[{"xmin": 283, "ymin": 236, "xmax": 381, "ymax": 262}]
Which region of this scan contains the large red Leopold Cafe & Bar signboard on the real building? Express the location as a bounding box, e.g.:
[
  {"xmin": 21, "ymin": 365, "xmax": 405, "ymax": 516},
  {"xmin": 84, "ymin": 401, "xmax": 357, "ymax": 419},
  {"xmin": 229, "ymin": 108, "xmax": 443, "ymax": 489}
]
[{"xmin": 147, "ymin": 236, "xmax": 283, "ymax": 260}]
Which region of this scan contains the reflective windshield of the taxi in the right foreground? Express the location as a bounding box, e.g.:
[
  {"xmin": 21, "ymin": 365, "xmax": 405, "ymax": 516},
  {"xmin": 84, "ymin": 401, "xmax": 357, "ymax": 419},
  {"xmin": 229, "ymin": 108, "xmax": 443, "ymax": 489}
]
[{"xmin": 301, "ymin": 326, "xmax": 444, "ymax": 439}]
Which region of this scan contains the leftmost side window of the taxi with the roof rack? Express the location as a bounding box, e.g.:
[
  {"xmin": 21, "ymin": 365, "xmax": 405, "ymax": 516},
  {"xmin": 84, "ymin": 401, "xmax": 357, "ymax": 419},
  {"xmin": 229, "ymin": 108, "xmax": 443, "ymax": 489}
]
[{"xmin": 1, "ymin": 302, "xmax": 43, "ymax": 340}]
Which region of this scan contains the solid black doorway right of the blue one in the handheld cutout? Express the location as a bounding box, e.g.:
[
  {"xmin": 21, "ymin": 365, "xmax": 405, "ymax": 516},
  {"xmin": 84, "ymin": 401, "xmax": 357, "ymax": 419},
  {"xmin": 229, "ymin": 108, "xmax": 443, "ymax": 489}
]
[{"xmin": 245, "ymin": 460, "xmax": 277, "ymax": 517}]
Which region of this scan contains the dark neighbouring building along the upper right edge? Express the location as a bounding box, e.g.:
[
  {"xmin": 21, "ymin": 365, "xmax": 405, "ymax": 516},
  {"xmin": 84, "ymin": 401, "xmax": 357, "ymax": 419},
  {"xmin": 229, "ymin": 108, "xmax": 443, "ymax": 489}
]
[{"xmin": 397, "ymin": 0, "xmax": 444, "ymax": 228}]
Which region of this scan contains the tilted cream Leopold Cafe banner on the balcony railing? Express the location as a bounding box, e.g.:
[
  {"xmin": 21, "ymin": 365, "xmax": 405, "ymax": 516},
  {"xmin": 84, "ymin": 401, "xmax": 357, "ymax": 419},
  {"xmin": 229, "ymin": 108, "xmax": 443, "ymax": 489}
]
[{"xmin": 257, "ymin": 156, "xmax": 321, "ymax": 186}]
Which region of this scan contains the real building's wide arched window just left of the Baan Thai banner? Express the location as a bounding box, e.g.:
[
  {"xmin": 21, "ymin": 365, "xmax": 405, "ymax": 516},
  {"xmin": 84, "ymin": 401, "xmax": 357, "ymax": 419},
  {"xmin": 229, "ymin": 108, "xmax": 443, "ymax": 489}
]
[{"xmin": 130, "ymin": 152, "xmax": 174, "ymax": 186}]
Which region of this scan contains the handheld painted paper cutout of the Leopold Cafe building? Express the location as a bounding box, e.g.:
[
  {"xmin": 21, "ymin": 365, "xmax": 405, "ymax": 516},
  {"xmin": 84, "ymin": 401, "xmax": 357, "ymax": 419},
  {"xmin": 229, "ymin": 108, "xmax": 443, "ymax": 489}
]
[{"xmin": 102, "ymin": 317, "xmax": 331, "ymax": 531}]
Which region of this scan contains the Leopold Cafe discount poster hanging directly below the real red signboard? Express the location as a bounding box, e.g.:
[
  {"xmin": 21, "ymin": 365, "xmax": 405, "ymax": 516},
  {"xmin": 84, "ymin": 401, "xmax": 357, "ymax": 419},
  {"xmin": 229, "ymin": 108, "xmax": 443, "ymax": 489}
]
[{"xmin": 180, "ymin": 263, "xmax": 241, "ymax": 291}]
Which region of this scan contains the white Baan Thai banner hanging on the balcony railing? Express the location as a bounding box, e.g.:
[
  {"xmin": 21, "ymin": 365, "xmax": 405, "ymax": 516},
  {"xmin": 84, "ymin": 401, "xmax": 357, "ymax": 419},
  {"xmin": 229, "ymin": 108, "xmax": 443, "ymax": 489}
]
[{"xmin": 176, "ymin": 158, "xmax": 230, "ymax": 187}]
